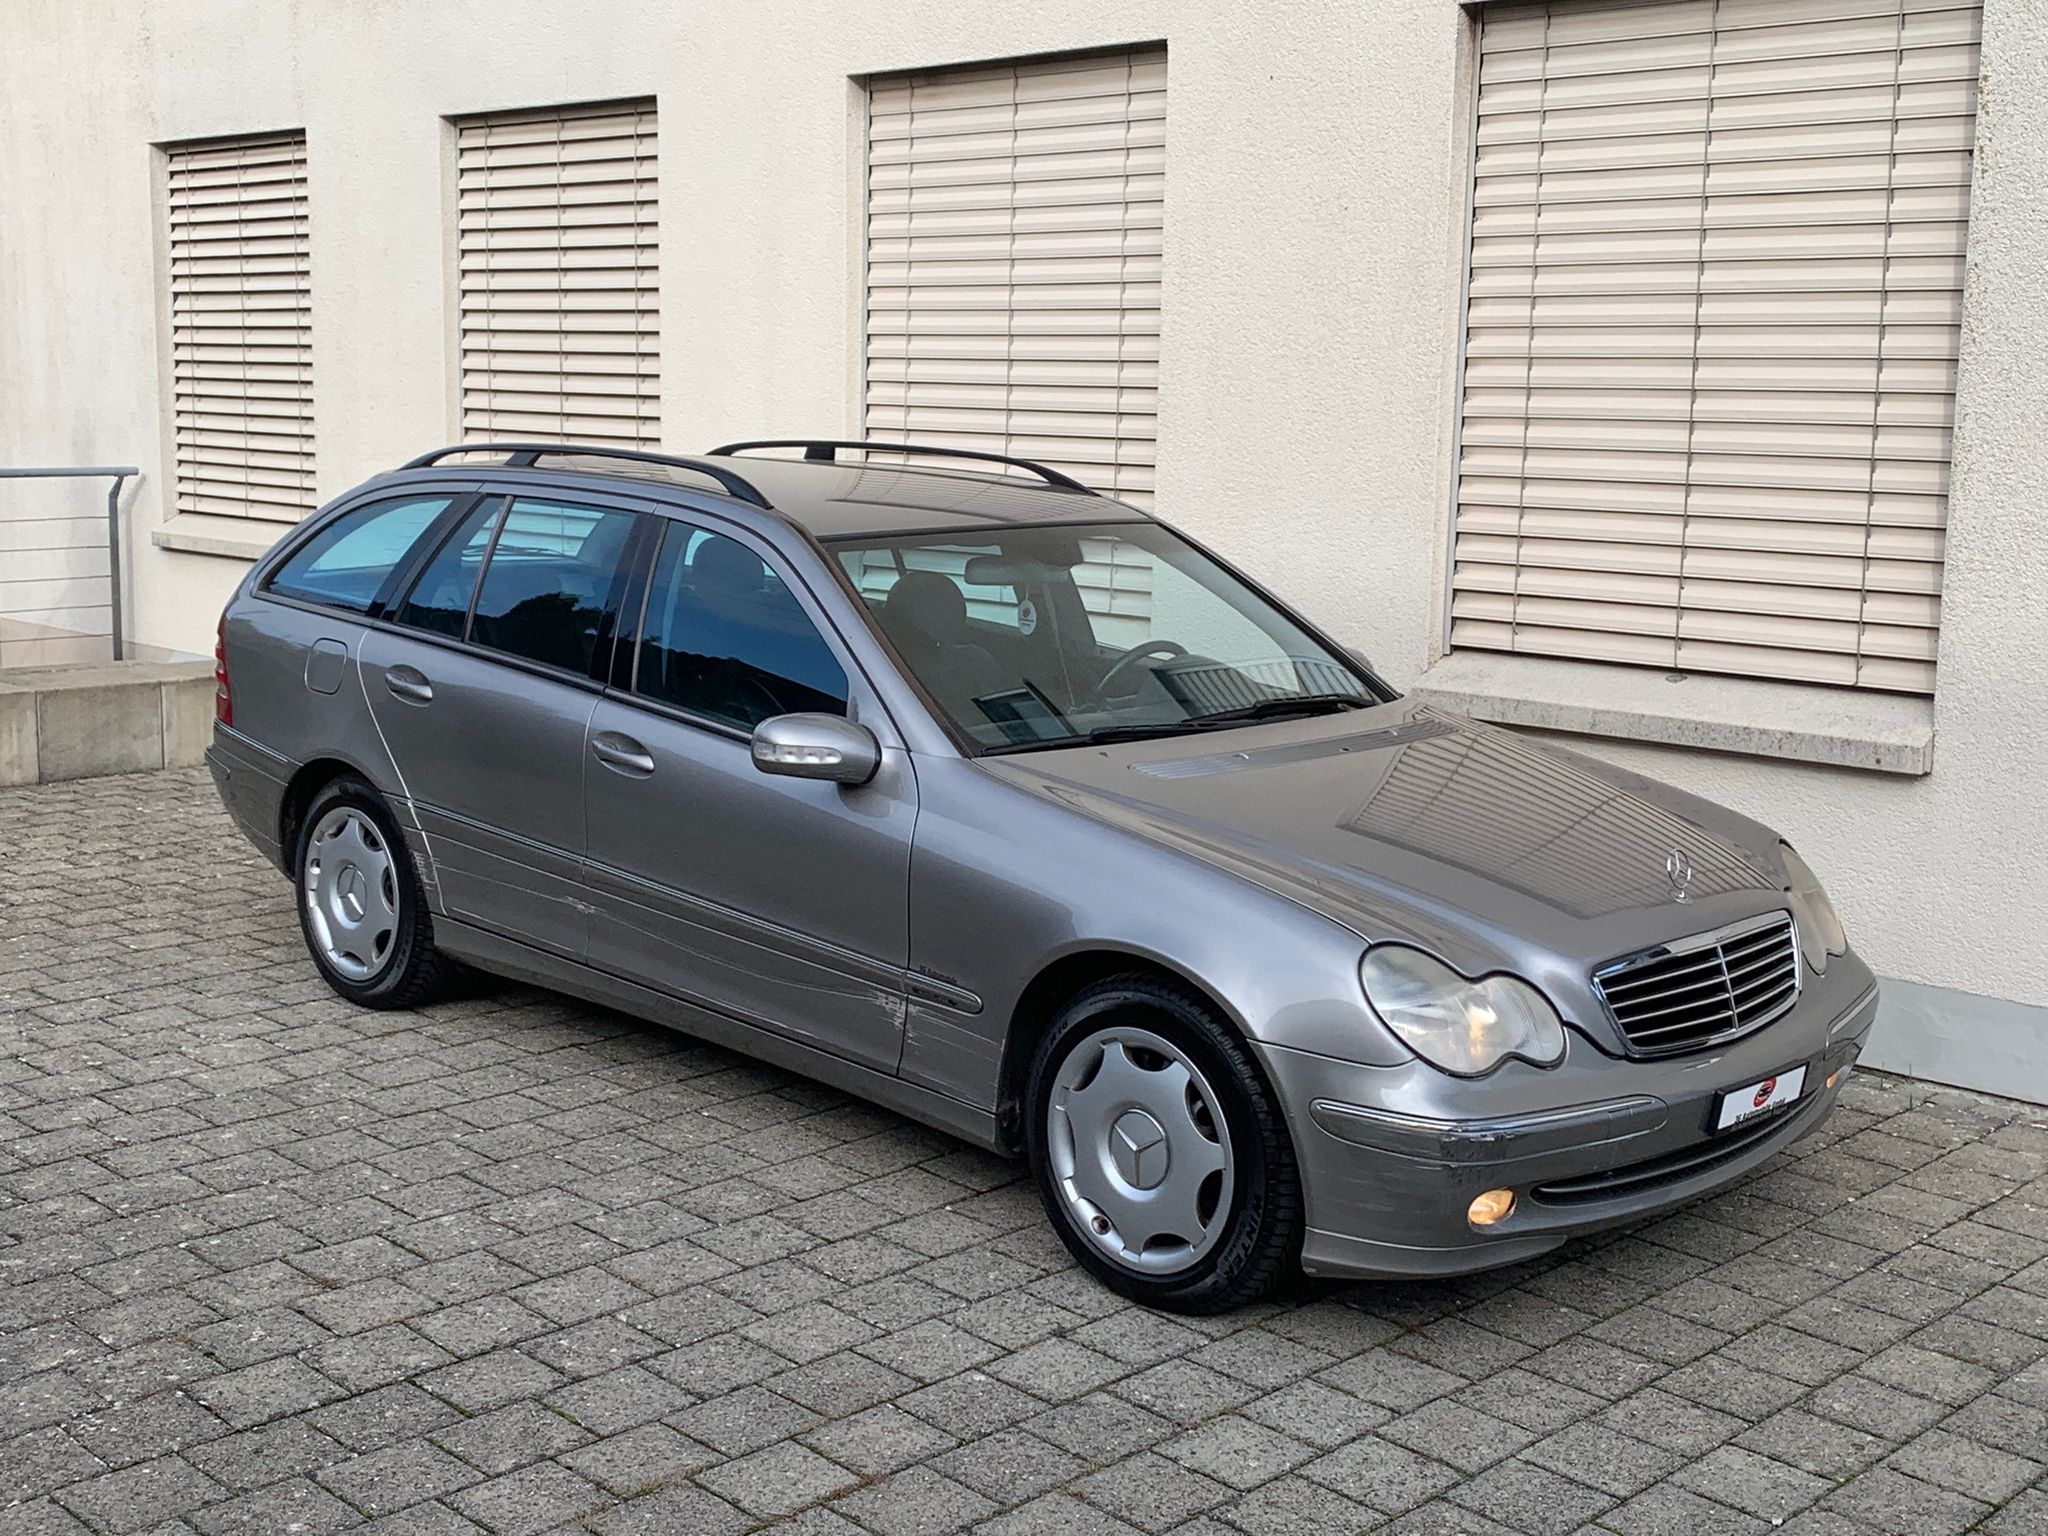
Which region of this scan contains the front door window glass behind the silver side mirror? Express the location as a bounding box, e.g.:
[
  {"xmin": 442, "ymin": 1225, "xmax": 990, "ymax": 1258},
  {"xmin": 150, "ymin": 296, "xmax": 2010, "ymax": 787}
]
[{"xmin": 633, "ymin": 522, "xmax": 846, "ymax": 731}]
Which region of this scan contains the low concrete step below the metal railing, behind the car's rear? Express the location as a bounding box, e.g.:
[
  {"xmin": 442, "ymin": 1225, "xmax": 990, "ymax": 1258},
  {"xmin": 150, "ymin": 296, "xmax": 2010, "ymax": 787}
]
[{"xmin": 0, "ymin": 662, "xmax": 213, "ymax": 784}]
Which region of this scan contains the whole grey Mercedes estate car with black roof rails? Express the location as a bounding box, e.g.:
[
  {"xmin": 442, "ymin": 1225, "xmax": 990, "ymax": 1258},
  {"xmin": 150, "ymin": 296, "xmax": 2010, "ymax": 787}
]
[{"xmin": 209, "ymin": 442, "xmax": 1876, "ymax": 1311}]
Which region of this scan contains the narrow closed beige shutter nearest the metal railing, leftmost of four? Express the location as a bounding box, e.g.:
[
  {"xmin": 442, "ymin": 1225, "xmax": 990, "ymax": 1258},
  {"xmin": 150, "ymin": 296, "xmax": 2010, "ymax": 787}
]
[{"xmin": 164, "ymin": 133, "xmax": 319, "ymax": 522}]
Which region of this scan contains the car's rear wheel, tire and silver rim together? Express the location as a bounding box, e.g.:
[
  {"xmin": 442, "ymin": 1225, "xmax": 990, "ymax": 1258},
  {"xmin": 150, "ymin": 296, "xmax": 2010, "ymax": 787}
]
[{"xmin": 297, "ymin": 774, "xmax": 457, "ymax": 1008}]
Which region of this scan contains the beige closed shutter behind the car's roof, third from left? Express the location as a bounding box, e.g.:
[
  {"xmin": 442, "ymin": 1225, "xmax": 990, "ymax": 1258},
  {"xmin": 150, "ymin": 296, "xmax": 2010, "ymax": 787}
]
[{"xmin": 866, "ymin": 47, "xmax": 1165, "ymax": 506}]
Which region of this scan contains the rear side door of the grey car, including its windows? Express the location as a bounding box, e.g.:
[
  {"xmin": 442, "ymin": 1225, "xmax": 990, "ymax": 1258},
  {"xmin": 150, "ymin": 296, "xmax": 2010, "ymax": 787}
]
[{"xmin": 362, "ymin": 496, "xmax": 639, "ymax": 958}]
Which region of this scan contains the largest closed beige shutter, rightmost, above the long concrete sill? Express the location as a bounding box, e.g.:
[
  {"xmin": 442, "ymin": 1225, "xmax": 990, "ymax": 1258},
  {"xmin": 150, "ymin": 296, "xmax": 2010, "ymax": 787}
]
[{"xmin": 1450, "ymin": 0, "xmax": 1978, "ymax": 692}]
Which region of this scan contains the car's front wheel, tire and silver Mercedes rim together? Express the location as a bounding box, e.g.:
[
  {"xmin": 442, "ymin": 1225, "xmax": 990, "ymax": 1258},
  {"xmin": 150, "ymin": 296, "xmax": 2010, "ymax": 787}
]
[{"xmin": 1026, "ymin": 975, "xmax": 1303, "ymax": 1313}]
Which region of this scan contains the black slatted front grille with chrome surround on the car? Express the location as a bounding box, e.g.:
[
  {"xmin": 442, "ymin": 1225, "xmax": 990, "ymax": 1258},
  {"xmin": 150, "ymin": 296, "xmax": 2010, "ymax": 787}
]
[{"xmin": 1593, "ymin": 911, "xmax": 1800, "ymax": 1057}]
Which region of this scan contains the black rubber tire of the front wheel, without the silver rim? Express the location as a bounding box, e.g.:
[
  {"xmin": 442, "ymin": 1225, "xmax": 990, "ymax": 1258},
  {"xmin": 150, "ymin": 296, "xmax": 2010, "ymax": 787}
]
[{"xmin": 1024, "ymin": 973, "xmax": 1303, "ymax": 1313}]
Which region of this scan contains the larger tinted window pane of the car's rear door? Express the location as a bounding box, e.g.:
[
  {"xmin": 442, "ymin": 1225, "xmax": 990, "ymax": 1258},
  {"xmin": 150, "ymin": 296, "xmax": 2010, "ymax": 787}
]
[{"xmin": 469, "ymin": 498, "xmax": 637, "ymax": 674}]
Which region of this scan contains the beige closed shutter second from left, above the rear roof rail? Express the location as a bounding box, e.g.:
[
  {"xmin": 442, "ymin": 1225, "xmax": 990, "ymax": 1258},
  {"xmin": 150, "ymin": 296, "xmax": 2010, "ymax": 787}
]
[{"xmin": 455, "ymin": 100, "xmax": 662, "ymax": 446}]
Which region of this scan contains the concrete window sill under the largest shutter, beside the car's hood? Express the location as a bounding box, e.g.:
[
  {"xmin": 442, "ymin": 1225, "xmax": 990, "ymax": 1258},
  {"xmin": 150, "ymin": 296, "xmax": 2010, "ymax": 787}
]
[{"xmin": 1411, "ymin": 651, "xmax": 1933, "ymax": 774}]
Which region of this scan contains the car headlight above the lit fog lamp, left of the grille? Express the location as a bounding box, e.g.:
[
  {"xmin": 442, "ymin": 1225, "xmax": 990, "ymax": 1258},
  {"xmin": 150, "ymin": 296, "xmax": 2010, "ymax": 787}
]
[{"xmin": 1358, "ymin": 944, "xmax": 1565, "ymax": 1077}]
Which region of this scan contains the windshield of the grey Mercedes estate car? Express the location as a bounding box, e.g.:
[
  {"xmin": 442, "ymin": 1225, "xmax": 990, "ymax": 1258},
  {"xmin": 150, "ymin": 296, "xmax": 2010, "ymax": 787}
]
[{"xmin": 831, "ymin": 522, "xmax": 1380, "ymax": 752}]
